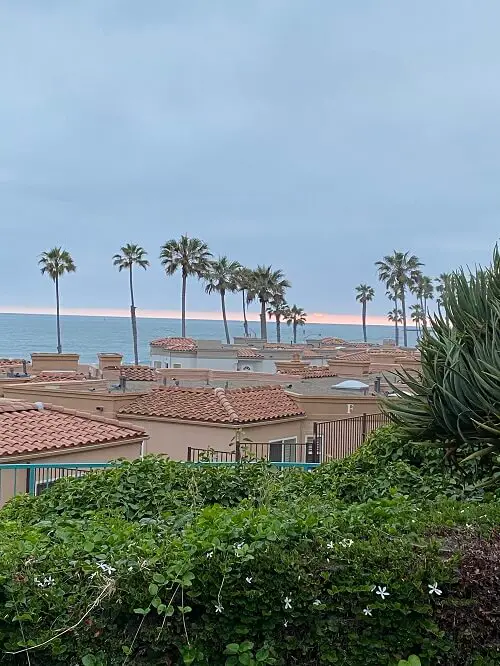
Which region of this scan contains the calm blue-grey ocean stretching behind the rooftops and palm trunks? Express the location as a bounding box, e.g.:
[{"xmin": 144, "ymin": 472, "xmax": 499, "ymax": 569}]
[{"xmin": 0, "ymin": 314, "xmax": 416, "ymax": 363}]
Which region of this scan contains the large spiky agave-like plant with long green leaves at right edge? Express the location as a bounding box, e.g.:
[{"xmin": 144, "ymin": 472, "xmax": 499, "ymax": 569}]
[{"xmin": 384, "ymin": 248, "xmax": 500, "ymax": 470}]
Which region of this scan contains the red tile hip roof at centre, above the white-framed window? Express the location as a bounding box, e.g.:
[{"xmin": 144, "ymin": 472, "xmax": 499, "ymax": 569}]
[{"xmin": 120, "ymin": 386, "xmax": 305, "ymax": 424}]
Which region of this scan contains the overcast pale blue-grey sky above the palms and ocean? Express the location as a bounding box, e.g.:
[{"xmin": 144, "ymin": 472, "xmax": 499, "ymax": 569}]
[{"xmin": 0, "ymin": 0, "xmax": 500, "ymax": 321}]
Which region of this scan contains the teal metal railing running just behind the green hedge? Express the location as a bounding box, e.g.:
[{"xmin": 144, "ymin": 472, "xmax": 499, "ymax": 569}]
[{"xmin": 0, "ymin": 461, "xmax": 319, "ymax": 503}]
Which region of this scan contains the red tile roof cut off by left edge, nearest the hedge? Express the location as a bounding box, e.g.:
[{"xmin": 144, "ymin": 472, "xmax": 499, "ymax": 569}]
[{"xmin": 0, "ymin": 400, "xmax": 147, "ymax": 457}]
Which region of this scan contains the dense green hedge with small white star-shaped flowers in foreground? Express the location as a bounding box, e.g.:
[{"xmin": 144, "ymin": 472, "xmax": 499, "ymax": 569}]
[{"xmin": 0, "ymin": 428, "xmax": 500, "ymax": 666}]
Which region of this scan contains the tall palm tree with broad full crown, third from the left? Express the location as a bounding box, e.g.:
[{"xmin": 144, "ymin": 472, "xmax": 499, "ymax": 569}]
[{"xmin": 160, "ymin": 236, "xmax": 212, "ymax": 338}]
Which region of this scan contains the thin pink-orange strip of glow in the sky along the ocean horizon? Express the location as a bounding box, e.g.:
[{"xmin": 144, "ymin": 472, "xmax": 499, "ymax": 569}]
[{"xmin": 0, "ymin": 306, "xmax": 389, "ymax": 326}]
